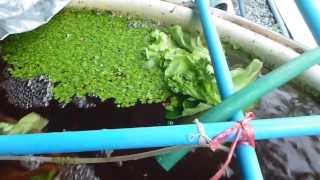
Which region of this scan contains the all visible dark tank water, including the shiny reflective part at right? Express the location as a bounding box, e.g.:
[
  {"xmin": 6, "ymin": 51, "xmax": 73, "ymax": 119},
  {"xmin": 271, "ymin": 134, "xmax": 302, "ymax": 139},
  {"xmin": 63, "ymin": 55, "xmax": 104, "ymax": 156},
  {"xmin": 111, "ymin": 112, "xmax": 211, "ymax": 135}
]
[{"xmin": 0, "ymin": 80, "xmax": 320, "ymax": 180}]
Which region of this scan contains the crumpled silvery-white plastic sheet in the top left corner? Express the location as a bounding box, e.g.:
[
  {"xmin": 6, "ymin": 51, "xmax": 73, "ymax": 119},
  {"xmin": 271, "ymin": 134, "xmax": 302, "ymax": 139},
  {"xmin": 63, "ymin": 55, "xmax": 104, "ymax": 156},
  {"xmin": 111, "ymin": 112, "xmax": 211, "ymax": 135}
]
[{"xmin": 0, "ymin": 0, "xmax": 70, "ymax": 40}]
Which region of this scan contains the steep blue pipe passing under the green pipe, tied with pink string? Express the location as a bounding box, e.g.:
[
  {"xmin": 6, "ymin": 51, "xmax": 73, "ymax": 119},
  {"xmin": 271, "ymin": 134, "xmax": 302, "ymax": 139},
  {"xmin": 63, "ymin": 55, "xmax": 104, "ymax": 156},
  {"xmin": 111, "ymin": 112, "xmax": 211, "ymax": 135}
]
[{"xmin": 196, "ymin": 0, "xmax": 263, "ymax": 180}]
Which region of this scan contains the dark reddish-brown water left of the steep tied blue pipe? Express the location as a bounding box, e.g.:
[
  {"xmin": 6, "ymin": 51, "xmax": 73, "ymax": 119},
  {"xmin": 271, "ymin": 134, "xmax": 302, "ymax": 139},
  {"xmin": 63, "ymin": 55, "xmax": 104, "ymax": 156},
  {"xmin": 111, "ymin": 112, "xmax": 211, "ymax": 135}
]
[{"xmin": 0, "ymin": 93, "xmax": 238, "ymax": 180}]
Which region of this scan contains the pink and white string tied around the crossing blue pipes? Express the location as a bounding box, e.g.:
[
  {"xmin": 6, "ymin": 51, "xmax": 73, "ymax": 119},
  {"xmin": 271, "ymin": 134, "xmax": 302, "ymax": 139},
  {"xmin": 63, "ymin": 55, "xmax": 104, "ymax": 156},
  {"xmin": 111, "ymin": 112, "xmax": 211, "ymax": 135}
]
[{"xmin": 194, "ymin": 112, "xmax": 255, "ymax": 180}]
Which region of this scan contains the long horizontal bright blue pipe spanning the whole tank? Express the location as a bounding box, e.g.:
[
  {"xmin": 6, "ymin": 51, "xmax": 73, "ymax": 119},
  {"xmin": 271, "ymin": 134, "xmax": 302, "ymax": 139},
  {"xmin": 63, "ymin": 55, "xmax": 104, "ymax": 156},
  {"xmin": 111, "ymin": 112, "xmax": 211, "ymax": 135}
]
[{"xmin": 0, "ymin": 116, "xmax": 320, "ymax": 155}]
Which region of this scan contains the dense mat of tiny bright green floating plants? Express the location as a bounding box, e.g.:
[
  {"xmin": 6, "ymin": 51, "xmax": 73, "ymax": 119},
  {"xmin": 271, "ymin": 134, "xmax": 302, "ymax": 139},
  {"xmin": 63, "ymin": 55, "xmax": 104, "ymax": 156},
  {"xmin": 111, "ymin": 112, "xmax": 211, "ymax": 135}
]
[{"xmin": 2, "ymin": 10, "xmax": 170, "ymax": 107}]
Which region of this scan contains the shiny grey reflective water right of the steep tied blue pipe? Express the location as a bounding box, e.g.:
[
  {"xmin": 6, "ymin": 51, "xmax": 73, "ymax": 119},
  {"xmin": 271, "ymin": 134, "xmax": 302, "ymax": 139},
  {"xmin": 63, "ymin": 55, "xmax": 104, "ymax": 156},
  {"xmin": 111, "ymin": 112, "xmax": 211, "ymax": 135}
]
[{"xmin": 255, "ymin": 86, "xmax": 320, "ymax": 179}]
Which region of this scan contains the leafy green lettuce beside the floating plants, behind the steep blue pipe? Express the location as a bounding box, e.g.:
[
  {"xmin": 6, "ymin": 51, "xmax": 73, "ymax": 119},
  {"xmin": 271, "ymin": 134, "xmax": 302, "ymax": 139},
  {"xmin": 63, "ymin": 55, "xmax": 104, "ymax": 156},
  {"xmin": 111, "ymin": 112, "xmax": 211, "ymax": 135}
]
[{"xmin": 145, "ymin": 26, "xmax": 262, "ymax": 119}]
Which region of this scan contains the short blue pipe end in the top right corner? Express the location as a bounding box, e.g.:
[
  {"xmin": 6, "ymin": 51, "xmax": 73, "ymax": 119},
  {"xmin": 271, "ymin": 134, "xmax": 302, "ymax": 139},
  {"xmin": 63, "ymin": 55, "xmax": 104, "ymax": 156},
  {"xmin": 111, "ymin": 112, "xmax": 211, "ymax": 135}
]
[{"xmin": 296, "ymin": 0, "xmax": 320, "ymax": 45}]
